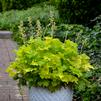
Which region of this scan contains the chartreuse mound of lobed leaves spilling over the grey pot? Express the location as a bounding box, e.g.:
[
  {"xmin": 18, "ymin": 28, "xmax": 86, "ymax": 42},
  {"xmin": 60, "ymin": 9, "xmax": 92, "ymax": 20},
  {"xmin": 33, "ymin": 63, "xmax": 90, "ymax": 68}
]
[{"xmin": 7, "ymin": 37, "xmax": 92, "ymax": 91}]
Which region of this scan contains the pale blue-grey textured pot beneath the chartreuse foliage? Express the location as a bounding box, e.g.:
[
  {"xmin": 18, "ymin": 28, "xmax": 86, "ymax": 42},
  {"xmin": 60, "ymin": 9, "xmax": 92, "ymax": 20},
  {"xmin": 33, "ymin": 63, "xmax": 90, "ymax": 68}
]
[{"xmin": 29, "ymin": 87, "xmax": 73, "ymax": 101}]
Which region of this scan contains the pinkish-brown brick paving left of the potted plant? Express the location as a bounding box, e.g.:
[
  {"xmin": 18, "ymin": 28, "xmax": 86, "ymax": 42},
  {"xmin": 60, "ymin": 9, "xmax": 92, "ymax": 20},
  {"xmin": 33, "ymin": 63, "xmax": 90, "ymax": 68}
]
[{"xmin": 0, "ymin": 31, "xmax": 29, "ymax": 101}]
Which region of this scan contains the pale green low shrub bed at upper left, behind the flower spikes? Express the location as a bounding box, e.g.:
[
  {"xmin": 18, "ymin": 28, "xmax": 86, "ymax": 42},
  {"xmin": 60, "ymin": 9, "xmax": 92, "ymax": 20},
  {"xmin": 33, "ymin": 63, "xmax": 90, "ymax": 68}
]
[{"xmin": 0, "ymin": 3, "xmax": 58, "ymax": 29}]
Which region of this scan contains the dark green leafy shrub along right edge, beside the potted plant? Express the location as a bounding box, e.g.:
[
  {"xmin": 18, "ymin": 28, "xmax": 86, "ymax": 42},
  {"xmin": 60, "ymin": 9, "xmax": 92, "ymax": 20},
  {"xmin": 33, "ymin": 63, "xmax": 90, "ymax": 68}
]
[{"xmin": 73, "ymin": 24, "xmax": 101, "ymax": 101}]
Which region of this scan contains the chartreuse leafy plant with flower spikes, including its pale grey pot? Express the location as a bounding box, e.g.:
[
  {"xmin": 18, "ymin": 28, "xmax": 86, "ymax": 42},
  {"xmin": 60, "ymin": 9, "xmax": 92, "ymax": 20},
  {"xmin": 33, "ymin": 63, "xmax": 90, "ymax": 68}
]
[{"xmin": 7, "ymin": 17, "xmax": 92, "ymax": 101}]
